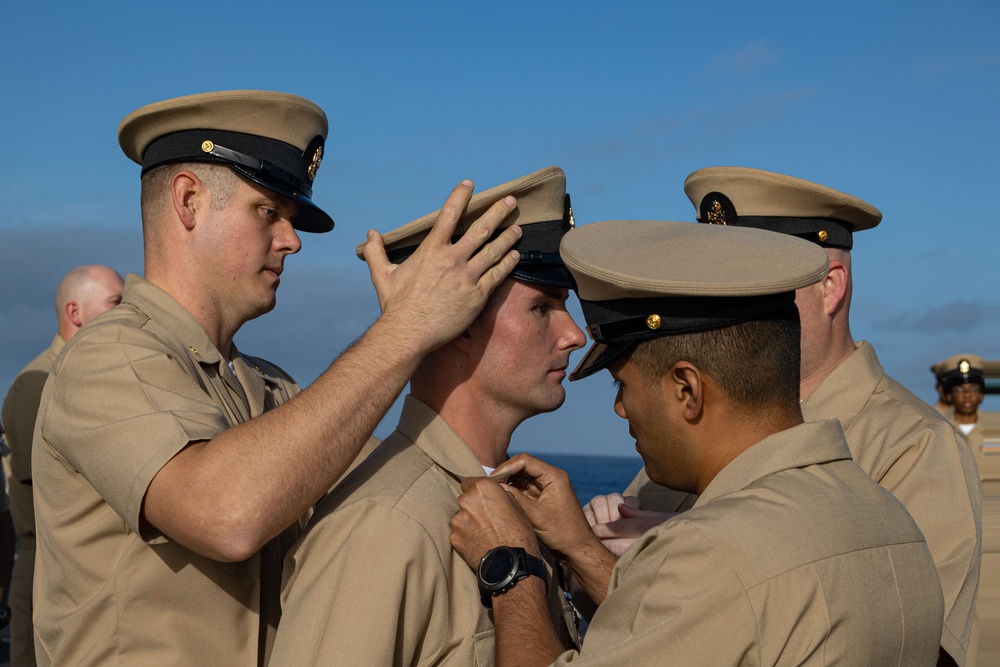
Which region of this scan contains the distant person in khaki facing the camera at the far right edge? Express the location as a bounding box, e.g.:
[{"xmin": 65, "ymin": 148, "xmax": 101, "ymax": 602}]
[{"xmin": 937, "ymin": 354, "xmax": 1000, "ymax": 667}]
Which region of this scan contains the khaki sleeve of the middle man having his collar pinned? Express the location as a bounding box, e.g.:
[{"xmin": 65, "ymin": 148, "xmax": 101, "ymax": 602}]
[{"xmin": 271, "ymin": 500, "xmax": 458, "ymax": 667}]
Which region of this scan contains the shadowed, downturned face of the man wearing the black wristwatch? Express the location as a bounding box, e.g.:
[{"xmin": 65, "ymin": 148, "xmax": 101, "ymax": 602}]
[{"xmin": 608, "ymin": 356, "xmax": 686, "ymax": 490}]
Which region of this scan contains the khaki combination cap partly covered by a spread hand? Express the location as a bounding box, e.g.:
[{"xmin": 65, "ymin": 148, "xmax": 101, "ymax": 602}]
[{"xmin": 356, "ymin": 167, "xmax": 575, "ymax": 289}]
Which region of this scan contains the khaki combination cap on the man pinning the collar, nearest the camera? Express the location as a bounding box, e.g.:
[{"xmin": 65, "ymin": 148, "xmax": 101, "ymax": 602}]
[{"xmin": 560, "ymin": 220, "xmax": 829, "ymax": 380}]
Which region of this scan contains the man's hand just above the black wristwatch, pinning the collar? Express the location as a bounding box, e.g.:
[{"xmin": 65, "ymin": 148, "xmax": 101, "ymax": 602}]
[{"xmin": 451, "ymin": 477, "xmax": 541, "ymax": 571}]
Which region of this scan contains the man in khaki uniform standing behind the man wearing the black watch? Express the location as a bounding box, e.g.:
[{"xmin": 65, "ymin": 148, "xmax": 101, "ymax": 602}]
[{"xmin": 597, "ymin": 167, "xmax": 981, "ymax": 664}]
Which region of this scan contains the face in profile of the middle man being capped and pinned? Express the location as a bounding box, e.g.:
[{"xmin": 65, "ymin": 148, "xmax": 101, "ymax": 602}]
[{"xmin": 468, "ymin": 279, "xmax": 586, "ymax": 420}]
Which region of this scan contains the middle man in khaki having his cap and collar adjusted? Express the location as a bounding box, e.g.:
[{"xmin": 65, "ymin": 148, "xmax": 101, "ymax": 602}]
[{"xmin": 272, "ymin": 167, "xmax": 586, "ymax": 667}]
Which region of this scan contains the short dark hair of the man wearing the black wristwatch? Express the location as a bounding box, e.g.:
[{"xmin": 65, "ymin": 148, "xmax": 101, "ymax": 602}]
[{"xmin": 630, "ymin": 304, "xmax": 801, "ymax": 409}]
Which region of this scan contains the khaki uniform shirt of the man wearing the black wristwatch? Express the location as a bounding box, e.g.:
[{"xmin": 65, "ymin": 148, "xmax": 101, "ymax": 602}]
[{"xmin": 555, "ymin": 420, "xmax": 943, "ymax": 667}]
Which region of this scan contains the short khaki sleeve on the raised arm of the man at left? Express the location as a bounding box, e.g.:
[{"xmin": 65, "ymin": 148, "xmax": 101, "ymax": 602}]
[{"xmin": 36, "ymin": 330, "xmax": 229, "ymax": 533}]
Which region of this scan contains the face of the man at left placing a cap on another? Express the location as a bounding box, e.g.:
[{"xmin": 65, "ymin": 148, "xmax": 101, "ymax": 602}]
[{"xmin": 201, "ymin": 179, "xmax": 302, "ymax": 321}]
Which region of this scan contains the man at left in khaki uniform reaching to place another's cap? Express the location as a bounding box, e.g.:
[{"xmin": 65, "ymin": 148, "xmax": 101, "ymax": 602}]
[{"xmin": 32, "ymin": 91, "xmax": 519, "ymax": 665}]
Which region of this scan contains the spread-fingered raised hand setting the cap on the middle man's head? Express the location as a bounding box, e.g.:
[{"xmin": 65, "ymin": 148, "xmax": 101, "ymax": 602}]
[{"xmin": 364, "ymin": 180, "xmax": 521, "ymax": 353}]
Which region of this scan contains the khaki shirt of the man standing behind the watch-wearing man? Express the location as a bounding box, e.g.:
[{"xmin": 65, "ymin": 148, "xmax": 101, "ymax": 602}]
[{"xmin": 629, "ymin": 342, "xmax": 982, "ymax": 665}]
